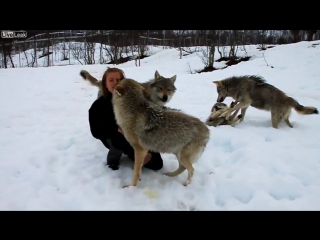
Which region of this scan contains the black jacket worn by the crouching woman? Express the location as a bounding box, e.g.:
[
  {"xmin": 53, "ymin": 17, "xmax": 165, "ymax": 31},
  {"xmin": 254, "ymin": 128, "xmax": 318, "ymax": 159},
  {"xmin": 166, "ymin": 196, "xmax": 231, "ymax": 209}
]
[{"xmin": 89, "ymin": 93, "xmax": 134, "ymax": 158}]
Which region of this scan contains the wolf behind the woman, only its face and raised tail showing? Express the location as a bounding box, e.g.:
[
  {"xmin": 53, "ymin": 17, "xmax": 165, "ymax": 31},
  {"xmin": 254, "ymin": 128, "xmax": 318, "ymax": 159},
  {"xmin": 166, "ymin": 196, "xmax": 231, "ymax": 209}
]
[{"xmin": 80, "ymin": 70, "xmax": 177, "ymax": 106}]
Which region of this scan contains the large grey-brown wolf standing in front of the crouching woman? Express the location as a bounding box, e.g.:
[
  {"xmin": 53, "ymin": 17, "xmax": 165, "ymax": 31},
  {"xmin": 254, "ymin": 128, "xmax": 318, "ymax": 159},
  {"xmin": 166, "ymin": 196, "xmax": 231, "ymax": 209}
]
[{"xmin": 112, "ymin": 79, "xmax": 210, "ymax": 186}]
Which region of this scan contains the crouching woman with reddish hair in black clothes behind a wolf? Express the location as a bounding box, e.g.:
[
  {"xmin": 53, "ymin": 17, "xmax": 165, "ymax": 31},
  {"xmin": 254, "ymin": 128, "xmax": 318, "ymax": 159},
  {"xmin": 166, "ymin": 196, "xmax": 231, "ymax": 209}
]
[{"xmin": 89, "ymin": 68, "xmax": 163, "ymax": 170}]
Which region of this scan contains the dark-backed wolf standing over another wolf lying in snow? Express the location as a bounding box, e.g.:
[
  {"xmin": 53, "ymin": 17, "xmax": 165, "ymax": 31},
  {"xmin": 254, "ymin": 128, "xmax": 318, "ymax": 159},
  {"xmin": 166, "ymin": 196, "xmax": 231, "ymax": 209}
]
[{"xmin": 213, "ymin": 76, "xmax": 319, "ymax": 128}]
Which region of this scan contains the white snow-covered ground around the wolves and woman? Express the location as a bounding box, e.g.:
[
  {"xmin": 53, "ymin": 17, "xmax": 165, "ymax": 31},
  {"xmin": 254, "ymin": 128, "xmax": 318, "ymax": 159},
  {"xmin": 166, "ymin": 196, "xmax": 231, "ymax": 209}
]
[{"xmin": 0, "ymin": 41, "xmax": 320, "ymax": 210}]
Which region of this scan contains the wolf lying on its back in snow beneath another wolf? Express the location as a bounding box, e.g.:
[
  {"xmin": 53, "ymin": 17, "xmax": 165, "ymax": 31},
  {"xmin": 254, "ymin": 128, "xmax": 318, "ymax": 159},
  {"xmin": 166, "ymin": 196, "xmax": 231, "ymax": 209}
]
[{"xmin": 206, "ymin": 102, "xmax": 242, "ymax": 127}]
